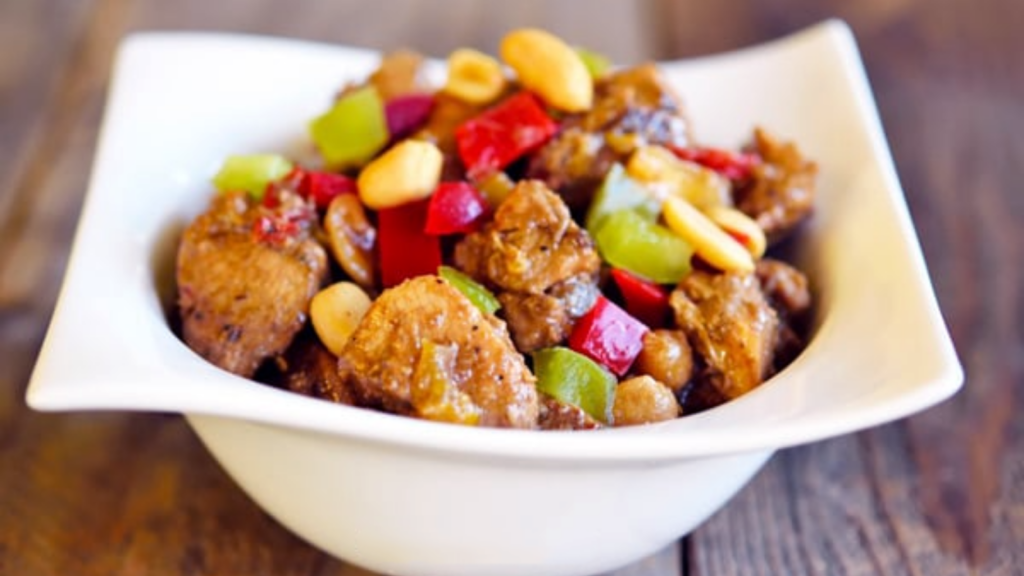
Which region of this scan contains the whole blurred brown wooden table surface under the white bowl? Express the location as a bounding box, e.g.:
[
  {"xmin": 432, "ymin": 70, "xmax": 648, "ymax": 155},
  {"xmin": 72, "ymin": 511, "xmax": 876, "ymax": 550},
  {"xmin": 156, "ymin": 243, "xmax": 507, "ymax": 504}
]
[{"xmin": 0, "ymin": 0, "xmax": 1024, "ymax": 576}]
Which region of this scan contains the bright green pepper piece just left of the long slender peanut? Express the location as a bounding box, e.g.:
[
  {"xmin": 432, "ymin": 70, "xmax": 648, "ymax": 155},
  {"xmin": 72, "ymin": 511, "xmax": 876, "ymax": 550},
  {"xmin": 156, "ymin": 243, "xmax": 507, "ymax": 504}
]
[{"xmin": 594, "ymin": 210, "xmax": 693, "ymax": 284}]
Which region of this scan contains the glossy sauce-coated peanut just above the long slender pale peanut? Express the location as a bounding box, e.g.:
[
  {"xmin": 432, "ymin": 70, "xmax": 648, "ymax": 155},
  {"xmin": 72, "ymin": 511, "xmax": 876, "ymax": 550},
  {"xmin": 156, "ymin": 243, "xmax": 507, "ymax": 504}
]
[{"xmin": 626, "ymin": 146, "xmax": 731, "ymax": 209}]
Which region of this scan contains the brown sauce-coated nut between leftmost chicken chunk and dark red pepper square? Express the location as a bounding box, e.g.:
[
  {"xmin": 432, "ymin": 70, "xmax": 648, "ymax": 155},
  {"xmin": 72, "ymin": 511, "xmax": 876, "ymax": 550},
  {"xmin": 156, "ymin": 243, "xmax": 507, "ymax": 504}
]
[{"xmin": 324, "ymin": 194, "xmax": 377, "ymax": 288}]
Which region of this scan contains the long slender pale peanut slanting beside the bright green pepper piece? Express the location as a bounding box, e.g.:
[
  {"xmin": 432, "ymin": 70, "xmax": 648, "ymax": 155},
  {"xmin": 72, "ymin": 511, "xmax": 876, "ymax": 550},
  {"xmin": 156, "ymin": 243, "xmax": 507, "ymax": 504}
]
[{"xmin": 662, "ymin": 196, "xmax": 754, "ymax": 272}]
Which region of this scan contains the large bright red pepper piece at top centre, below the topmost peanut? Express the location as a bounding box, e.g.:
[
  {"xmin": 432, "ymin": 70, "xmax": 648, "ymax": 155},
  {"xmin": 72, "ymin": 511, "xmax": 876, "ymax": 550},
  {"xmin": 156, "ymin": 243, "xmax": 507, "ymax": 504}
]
[{"xmin": 455, "ymin": 91, "xmax": 558, "ymax": 179}]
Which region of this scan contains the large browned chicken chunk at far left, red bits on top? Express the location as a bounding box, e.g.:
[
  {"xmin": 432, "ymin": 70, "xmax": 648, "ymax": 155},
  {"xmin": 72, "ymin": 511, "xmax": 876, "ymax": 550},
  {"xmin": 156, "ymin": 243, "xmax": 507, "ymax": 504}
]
[{"xmin": 177, "ymin": 191, "xmax": 328, "ymax": 377}]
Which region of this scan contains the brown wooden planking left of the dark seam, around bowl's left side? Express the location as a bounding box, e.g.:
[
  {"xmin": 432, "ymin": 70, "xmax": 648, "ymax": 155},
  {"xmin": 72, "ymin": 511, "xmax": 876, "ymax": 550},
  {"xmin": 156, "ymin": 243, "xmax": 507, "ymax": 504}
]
[{"xmin": 0, "ymin": 0, "xmax": 679, "ymax": 576}]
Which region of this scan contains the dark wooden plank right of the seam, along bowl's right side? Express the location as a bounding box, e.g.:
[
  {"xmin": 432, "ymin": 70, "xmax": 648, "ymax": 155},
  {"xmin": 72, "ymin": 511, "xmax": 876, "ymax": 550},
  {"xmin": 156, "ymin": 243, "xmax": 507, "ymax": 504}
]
[{"xmin": 669, "ymin": 0, "xmax": 1024, "ymax": 576}]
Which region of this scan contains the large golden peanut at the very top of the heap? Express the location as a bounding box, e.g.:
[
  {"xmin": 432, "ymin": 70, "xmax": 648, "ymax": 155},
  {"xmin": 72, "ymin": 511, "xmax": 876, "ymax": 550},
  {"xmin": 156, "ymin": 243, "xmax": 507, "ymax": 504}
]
[{"xmin": 499, "ymin": 28, "xmax": 594, "ymax": 112}]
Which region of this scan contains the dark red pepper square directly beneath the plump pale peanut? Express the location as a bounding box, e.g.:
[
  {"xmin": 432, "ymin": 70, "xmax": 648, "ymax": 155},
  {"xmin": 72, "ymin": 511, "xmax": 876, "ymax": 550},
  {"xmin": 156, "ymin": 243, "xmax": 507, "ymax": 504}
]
[{"xmin": 377, "ymin": 200, "xmax": 441, "ymax": 288}]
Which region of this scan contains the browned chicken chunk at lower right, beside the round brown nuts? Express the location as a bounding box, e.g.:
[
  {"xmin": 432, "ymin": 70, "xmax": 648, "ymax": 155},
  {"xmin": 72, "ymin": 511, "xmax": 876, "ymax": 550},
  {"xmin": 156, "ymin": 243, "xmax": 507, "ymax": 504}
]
[{"xmin": 670, "ymin": 271, "xmax": 778, "ymax": 400}]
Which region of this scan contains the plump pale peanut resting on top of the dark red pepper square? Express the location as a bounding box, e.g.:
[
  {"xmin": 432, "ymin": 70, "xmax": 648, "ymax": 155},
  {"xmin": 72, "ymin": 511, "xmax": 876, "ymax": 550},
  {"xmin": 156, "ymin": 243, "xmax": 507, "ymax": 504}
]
[{"xmin": 356, "ymin": 140, "xmax": 444, "ymax": 210}]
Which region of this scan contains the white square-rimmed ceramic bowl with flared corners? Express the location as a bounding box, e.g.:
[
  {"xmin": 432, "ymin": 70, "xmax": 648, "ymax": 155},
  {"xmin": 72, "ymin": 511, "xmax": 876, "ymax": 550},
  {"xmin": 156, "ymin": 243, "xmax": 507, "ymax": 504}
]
[{"xmin": 28, "ymin": 22, "xmax": 963, "ymax": 576}]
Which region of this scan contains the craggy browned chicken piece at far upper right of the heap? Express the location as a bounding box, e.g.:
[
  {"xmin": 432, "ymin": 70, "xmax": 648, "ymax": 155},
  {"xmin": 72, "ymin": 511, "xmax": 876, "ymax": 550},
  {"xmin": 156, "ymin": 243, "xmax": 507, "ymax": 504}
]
[{"xmin": 733, "ymin": 128, "xmax": 818, "ymax": 245}]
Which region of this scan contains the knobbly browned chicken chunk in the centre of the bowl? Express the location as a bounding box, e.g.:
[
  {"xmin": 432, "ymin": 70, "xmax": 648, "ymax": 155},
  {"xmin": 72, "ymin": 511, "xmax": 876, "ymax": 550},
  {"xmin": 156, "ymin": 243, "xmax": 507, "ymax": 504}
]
[{"xmin": 455, "ymin": 180, "xmax": 601, "ymax": 353}]
